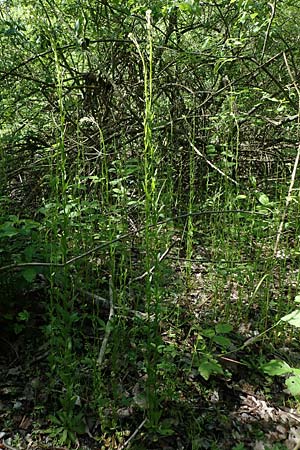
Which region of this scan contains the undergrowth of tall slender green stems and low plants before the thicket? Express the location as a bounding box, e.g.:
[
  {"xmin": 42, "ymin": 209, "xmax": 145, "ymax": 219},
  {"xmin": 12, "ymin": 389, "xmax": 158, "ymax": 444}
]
[{"xmin": 0, "ymin": 2, "xmax": 300, "ymax": 450}]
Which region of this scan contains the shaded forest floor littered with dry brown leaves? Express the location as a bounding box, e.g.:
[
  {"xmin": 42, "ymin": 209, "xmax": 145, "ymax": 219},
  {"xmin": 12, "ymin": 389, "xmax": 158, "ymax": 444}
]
[{"xmin": 0, "ymin": 262, "xmax": 300, "ymax": 450}]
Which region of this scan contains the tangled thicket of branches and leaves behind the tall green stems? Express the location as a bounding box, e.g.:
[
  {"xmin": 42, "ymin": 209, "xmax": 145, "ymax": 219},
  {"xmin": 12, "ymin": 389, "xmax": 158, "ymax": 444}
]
[{"xmin": 1, "ymin": 1, "xmax": 299, "ymax": 218}]
